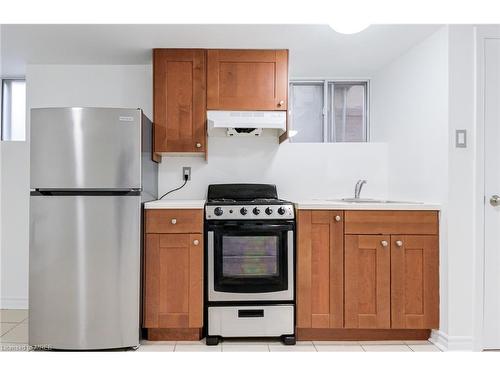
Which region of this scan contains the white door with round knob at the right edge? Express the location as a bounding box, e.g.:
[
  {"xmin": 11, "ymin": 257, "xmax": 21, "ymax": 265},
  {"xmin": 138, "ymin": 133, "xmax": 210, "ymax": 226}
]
[{"xmin": 483, "ymin": 39, "xmax": 500, "ymax": 349}]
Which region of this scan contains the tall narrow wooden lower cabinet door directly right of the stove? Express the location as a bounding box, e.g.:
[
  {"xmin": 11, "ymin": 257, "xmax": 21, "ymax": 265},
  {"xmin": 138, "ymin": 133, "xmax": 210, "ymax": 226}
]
[{"xmin": 297, "ymin": 210, "xmax": 344, "ymax": 328}]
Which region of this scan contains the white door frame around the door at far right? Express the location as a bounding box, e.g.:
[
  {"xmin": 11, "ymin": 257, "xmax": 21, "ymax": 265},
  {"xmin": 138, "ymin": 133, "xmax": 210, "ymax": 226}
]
[{"xmin": 473, "ymin": 25, "xmax": 500, "ymax": 351}]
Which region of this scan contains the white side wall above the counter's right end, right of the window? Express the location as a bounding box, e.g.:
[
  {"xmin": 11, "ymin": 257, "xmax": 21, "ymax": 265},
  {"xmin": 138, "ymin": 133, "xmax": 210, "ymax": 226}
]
[{"xmin": 371, "ymin": 27, "xmax": 448, "ymax": 206}]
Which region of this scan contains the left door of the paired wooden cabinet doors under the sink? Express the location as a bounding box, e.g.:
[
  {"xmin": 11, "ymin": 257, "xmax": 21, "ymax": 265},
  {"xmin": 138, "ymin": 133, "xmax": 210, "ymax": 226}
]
[{"xmin": 344, "ymin": 235, "xmax": 391, "ymax": 328}]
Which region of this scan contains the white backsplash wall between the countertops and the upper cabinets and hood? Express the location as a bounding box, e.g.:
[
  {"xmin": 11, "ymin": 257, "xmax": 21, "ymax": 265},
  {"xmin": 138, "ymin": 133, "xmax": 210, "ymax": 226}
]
[{"xmin": 159, "ymin": 137, "xmax": 388, "ymax": 200}]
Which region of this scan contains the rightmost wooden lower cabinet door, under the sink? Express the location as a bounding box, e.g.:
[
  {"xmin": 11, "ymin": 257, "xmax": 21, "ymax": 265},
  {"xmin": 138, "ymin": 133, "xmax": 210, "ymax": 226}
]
[{"xmin": 391, "ymin": 236, "xmax": 439, "ymax": 329}]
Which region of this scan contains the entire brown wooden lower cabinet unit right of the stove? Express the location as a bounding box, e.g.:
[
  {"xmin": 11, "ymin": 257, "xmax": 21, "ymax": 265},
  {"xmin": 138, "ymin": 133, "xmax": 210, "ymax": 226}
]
[{"xmin": 297, "ymin": 210, "xmax": 439, "ymax": 340}]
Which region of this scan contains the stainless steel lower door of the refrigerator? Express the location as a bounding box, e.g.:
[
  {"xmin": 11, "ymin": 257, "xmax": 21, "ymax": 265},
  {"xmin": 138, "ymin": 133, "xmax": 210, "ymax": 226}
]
[{"xmin": 29, "ymin": 195, "xmax": 141, "ymax": 350}]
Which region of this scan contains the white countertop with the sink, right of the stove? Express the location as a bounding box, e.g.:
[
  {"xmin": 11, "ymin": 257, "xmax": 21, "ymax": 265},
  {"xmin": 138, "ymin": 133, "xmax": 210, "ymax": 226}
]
[{"xmin": 295, "ymin": 199, "xmax": 441, "ymax": 211}]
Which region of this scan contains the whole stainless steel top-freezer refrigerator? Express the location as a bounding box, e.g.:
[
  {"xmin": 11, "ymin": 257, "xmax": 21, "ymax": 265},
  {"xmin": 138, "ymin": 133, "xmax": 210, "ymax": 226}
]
[{"xmin": 29, "ymin": 108, "xmax": 158, "ymax": 350}]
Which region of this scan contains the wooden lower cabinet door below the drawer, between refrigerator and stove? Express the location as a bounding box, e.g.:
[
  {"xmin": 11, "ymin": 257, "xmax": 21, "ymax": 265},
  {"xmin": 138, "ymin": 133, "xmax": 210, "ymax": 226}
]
[{"xmin": 144, "ymin": 233, "xmax": 203, "ymax": 328}]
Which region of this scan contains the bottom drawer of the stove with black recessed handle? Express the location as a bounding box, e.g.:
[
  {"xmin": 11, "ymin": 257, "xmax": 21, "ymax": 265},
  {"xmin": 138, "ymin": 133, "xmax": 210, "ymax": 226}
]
[{"xmin": 208, "ymin": 305, "xmax": 294, "ymax": 337}]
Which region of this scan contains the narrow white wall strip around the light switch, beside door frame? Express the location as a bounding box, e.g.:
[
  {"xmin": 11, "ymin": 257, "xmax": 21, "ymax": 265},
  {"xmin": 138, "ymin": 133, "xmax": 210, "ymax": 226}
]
[{"xmin": 447, "ymin": 26, "xmax": 476, "ymax": 349}]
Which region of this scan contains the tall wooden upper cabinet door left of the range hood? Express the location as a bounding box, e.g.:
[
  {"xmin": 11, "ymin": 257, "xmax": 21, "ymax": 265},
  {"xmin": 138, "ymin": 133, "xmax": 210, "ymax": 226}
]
[{"xmin": 153, "ymin": 49, "xmax": 206, "ymax": 152}]
